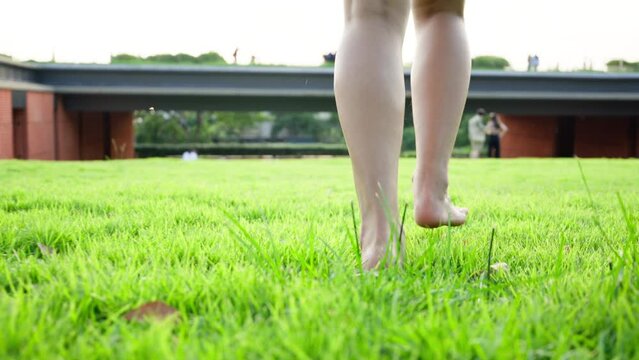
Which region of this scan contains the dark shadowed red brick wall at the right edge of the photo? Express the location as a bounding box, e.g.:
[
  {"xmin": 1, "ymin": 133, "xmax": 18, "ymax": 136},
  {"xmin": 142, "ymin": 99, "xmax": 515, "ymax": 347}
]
[{"xmin": 575, "ymin": 118, "xmax": 635, "ymax": 157}]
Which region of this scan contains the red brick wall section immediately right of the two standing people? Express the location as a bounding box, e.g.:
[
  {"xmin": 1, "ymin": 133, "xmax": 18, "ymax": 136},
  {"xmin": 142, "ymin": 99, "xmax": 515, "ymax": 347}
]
[{"xmin": 499, "ymin": 115, "xmax": 558, "ymax": 158}]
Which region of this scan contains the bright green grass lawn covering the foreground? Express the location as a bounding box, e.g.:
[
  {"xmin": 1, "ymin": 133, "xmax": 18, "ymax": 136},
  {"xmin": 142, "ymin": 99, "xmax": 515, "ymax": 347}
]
[{"xmin": 0, "ymin": 159, "xmax": 639, "ymax": 359}]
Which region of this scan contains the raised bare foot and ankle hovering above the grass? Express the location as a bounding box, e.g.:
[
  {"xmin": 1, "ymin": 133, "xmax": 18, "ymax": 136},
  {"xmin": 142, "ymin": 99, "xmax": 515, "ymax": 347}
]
[{"xmin": 413, "ymin": 172, "xmax": 468, "ymax": 228}]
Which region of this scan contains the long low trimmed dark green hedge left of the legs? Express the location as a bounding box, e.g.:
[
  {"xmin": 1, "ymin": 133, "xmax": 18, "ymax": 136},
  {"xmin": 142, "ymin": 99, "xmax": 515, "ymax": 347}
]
[{"xmin": 135, "ymin": 143, "xmax": 348, "ymax": 158}]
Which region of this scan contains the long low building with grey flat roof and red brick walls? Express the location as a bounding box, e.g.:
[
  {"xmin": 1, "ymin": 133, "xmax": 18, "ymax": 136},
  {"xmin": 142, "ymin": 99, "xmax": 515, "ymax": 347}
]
[{"xmin": 0, "ymin": 59, "xmax": 639, "ymax": 160}]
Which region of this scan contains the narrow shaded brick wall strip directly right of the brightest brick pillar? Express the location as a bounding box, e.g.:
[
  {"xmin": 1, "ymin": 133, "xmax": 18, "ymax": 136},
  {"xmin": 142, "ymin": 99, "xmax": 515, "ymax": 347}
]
[{"xmin": 55, "ymin": 98, "xmax": 80, "ymax": 160}]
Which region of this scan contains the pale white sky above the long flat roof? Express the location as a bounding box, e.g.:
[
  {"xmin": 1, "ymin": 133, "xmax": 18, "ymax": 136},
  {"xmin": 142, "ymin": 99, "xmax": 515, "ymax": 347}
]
[{"xmin": 0, "ymin": 0, "xmax": 639, "ymax": 70}]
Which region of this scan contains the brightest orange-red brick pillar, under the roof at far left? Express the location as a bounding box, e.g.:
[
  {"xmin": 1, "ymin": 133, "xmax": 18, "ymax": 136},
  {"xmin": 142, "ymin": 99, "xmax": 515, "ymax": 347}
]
[{"xmin": 26, "ymin": 92, "xmax": 55, "ymax": 160}]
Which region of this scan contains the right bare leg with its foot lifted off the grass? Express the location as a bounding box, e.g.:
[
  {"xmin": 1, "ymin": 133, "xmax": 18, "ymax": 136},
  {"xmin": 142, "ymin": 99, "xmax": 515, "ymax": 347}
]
[{"xmin": 411, "ymin": 10, "xmax": 470, "ymax": 227}]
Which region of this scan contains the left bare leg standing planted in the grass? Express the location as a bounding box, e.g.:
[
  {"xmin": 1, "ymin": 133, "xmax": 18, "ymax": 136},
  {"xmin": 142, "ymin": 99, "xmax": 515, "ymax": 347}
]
[{"xmin": 335, "ymin": 0, "xmax": 409, "ymax": 269}]
